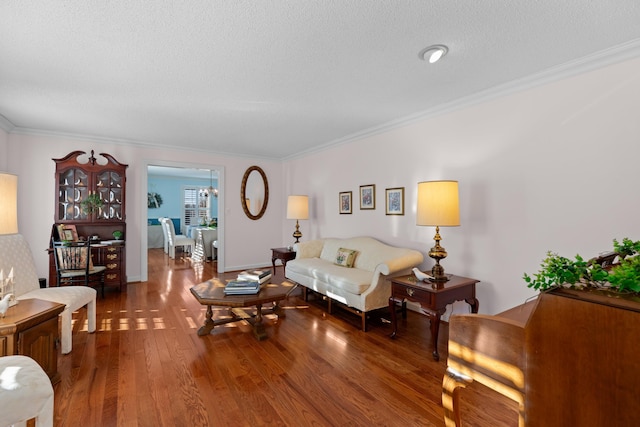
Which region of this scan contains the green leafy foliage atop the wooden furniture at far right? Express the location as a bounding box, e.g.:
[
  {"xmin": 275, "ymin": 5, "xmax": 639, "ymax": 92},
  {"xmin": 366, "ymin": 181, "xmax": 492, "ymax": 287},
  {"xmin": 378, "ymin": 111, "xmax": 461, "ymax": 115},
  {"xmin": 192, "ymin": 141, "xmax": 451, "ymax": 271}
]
[{"xmin": 523, "ymin": 238, "xmax": 640, "ymax": 293}]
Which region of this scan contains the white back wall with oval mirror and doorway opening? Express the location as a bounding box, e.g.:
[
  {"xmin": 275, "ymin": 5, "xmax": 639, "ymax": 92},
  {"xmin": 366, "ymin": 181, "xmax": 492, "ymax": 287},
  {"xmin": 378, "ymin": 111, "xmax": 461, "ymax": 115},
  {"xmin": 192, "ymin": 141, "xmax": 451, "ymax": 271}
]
[{"xmin": 5, "ymin": 134, "xmax": 283, "ymax": 281}]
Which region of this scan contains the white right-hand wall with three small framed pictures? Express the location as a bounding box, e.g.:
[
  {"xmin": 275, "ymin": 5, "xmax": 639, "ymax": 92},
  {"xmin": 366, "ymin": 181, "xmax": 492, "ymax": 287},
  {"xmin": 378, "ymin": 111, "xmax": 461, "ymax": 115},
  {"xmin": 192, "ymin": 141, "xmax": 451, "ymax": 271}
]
[{"xmin": 283, "ymin": 59, "xmax": 640, "ymax": 314}]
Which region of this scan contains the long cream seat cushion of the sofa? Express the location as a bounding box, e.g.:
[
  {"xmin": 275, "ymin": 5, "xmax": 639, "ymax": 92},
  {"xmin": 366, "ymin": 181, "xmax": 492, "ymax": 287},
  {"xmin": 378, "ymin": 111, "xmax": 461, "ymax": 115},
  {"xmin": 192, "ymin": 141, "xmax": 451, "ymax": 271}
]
[{"xmin": 287, "ymin": 258, "xmax": 373, "ymax": 295}]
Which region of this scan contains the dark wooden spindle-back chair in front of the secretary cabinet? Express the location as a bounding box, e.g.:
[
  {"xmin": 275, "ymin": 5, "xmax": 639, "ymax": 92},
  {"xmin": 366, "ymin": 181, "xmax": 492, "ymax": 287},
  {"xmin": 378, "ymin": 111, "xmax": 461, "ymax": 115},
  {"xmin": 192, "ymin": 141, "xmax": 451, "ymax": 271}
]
[{"xmin": 53, "ymin": 240, "xmax": 107, "ymax": 298}]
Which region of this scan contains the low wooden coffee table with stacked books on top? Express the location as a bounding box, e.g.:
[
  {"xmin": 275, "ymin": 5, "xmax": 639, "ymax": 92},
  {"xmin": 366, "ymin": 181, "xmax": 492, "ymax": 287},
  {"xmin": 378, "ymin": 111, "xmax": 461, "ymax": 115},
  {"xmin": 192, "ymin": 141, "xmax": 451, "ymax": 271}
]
[{"xmin": 191, "ymin": 279, "xmax": 296, "ymax": 341}]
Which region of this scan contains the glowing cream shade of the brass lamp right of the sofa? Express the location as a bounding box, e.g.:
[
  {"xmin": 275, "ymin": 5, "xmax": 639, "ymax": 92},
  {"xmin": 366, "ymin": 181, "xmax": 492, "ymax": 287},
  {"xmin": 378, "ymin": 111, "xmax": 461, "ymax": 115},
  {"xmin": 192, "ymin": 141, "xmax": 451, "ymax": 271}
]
[{"xmin": 416, "ymin": 181, "xmax": 460, "ymax": 227}]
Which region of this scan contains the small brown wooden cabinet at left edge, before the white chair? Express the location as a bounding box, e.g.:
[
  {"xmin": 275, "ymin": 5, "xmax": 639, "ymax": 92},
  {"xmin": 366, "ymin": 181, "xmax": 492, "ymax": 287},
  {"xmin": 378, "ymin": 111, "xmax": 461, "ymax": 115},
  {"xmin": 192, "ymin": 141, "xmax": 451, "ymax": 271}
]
[{"xmin": 0, "ymin": 299, "xmax": 65, "ymax": 384}]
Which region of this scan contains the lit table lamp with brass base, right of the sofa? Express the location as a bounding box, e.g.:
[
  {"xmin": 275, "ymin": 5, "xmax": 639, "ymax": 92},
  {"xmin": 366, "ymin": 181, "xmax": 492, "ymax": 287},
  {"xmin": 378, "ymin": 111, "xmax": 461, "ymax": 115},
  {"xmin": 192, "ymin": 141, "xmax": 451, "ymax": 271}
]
[{"xmin": 416, "ymin": 181, "xmax": 460, "ymax": 282}]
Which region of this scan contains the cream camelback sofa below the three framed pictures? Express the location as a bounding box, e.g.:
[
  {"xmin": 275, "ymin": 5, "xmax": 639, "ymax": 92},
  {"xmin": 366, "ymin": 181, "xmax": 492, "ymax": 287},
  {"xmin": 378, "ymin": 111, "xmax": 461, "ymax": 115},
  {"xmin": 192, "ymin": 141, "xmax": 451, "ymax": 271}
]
[{"xmin": 285, "ymin": 237, "xmax": 424, "ymax": 331}]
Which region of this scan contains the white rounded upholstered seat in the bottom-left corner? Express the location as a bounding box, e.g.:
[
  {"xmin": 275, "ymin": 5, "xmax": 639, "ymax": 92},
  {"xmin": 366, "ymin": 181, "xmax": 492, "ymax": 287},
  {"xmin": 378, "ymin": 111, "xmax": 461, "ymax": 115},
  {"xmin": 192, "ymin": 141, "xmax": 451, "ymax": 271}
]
[{"xmin": 0, "ymin": 356, "xmax": 53, "ymax": 427}]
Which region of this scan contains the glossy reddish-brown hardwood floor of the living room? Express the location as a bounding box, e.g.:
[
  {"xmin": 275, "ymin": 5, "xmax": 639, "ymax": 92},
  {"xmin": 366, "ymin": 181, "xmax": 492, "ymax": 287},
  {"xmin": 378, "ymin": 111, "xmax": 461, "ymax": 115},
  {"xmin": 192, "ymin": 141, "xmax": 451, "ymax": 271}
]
[{"xmin": 55, "ymin": 249, "xmax": 517, "ymax": 427}]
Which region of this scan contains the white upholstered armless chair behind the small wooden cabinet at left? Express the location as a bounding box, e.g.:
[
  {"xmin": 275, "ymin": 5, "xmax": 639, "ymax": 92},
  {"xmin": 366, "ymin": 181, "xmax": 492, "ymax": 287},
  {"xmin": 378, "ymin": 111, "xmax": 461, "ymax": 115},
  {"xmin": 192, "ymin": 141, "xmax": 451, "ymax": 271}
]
[{"xmin": 0, "ymin": 234, "xmax": 97, "ymax": 354}]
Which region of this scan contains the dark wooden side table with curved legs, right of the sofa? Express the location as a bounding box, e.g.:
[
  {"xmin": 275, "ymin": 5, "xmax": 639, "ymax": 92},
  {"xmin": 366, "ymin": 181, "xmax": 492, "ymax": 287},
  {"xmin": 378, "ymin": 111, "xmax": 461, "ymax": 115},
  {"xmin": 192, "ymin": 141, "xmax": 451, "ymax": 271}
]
[{"xmin": 389, "ymin": 275, "xmax": 479, "ymax": 360}]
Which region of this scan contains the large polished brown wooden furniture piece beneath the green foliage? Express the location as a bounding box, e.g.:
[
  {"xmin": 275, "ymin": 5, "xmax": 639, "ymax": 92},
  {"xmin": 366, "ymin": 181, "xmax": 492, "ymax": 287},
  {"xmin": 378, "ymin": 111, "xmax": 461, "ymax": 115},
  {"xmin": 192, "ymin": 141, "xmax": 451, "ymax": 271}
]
[{"xmin": 442, "ymin": 289, "xmax": 640, "ymax": 427}]
